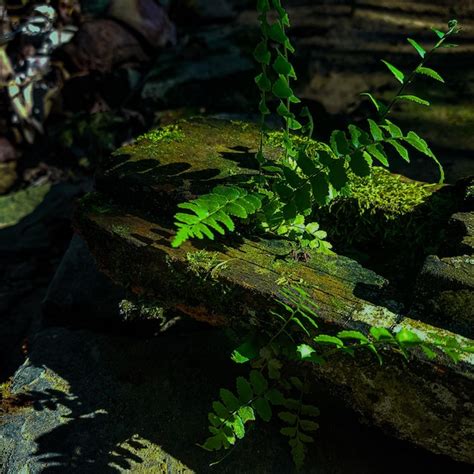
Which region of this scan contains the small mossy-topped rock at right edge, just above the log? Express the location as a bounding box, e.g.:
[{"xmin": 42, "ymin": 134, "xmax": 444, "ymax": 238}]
[{"xmin": 410, "ymin": 255, "xmax": 474, "ymax": 338}]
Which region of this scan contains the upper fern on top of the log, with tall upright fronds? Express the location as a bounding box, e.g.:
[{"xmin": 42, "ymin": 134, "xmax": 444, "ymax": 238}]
[{"xmin": 172, "ymin": 0, "xmax": 460, "ymax": 252}]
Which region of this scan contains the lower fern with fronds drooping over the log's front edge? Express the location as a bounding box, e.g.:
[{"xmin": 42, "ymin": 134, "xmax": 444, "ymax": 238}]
[{"xmin": 200, "ymin": 287, "xmax": 474, "ymax": 469}]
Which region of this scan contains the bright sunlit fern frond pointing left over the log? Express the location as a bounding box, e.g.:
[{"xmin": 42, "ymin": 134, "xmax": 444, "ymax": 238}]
[{"xmin": 171, "ymin": 186, "xmax": 262, "ymax": 247}]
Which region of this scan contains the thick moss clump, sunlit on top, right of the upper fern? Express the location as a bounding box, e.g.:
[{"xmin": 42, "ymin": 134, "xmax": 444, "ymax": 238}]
[{"xmin": 314, "ymin": 167, "xmax": 455, "ymax": 251}]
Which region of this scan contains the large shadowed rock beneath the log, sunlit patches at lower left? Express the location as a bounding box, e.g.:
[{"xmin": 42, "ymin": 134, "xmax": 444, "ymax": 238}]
[{"xmin": 0, "ymin": 328, "xmax": 472, "ymax": 474}]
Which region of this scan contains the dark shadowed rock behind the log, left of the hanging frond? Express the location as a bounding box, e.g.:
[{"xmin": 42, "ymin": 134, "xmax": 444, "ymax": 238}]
[{"xmin": 141, "ymin": 25, "xmax": 258, "ymax": 112}]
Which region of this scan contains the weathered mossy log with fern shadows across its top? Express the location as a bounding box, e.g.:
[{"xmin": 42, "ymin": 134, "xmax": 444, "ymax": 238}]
[{"xmin": 75, "ymin": 119, "xmax": 474, "ymax": 462}]
